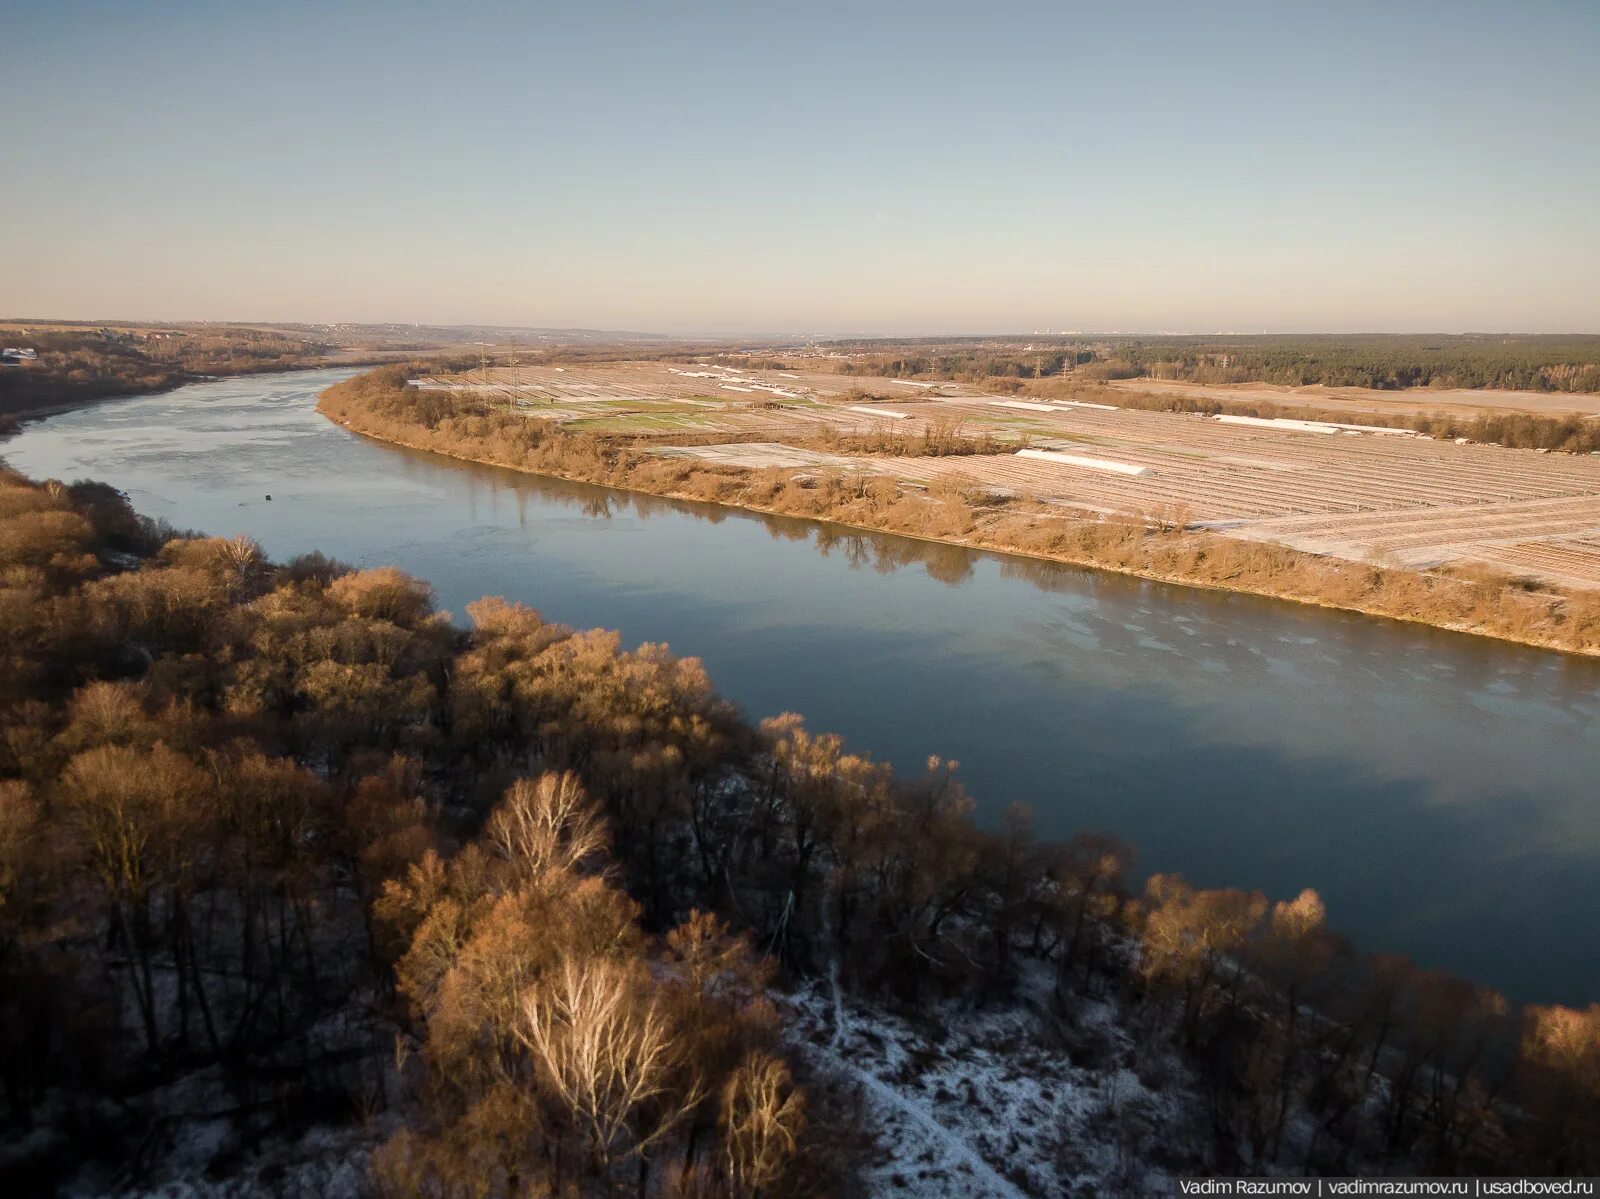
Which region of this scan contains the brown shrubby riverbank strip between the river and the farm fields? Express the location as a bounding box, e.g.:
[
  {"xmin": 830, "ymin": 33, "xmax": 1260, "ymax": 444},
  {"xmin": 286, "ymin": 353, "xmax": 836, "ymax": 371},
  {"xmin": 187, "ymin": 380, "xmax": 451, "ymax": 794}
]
[{"xmin": 318, "ymin": 370, "xmax": 1600, "ymax": 656}]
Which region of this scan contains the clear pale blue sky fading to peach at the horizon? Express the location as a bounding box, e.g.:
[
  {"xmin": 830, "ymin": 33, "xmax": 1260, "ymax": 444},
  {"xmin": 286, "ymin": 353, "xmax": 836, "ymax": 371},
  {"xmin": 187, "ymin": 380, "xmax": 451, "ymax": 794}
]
[{"xmin": 0, "ymin": 0, "xmax": 1600, "ymax": 335}]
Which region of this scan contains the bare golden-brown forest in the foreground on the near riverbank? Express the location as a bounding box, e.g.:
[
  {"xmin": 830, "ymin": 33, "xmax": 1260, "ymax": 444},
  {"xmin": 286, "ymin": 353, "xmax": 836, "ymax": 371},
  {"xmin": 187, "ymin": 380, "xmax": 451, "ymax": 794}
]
[{"xmin": 9, "ymin": 419, "xmax": 1600, "ymax": 1199}]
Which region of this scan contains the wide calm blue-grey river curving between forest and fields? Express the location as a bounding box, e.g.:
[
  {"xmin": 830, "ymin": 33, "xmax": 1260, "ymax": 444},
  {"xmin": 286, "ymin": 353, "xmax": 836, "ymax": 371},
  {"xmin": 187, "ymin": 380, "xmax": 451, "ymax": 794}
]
[{"xmin": 0, "ymin": 371, "xmax": 1600, "ymax": 1002}]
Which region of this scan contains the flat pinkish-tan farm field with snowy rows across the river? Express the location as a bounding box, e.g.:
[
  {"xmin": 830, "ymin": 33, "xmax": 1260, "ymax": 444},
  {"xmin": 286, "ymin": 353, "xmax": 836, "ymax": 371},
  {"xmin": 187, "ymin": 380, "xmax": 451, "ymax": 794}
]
[{"xmin": 419, "ymin": 362, "xmax": 1600, "ymax": 587}]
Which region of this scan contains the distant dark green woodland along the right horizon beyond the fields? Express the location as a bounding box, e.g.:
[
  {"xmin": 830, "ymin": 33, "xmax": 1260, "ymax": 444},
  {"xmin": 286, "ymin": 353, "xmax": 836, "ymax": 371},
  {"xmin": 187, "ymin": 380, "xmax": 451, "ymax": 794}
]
[{"xmin": 827, "ymin": 333, "xmax": 1600, "ymax": 392}]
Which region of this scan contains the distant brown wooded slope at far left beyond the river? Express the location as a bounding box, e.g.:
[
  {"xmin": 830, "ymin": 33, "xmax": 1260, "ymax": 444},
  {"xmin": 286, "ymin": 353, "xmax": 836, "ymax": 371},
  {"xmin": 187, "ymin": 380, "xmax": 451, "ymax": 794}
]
[{"xmin": 0, "ymin": 325, "xmax": 336, "ymax": 421}]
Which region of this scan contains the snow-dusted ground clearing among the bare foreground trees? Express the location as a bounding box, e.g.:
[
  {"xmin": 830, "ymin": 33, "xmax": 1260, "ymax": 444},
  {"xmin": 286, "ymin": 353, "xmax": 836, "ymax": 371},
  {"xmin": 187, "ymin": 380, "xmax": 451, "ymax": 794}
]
[{"xmin": 790, "ymin": 960, "xmax": 1202, "ymax": 1199}]
